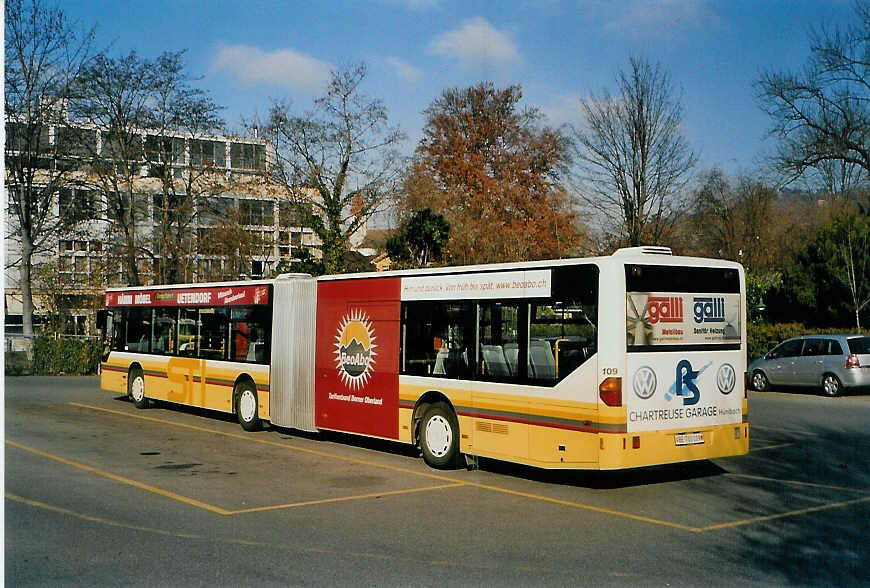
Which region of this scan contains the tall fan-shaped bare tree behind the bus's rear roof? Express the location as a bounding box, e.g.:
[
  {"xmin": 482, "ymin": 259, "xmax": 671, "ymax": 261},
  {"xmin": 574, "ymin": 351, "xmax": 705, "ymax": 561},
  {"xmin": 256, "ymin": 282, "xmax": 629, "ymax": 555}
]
[{"xmin": 574, "ymin": 57, "xmax": 697, "ymax": 245}]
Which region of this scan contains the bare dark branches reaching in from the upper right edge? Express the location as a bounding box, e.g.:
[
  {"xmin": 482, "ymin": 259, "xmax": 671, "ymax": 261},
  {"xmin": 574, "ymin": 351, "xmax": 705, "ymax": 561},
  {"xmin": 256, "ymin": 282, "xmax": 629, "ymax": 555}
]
[{"xmin": 756, "ymin": 1, "xmax": 870, "ymax": 187}]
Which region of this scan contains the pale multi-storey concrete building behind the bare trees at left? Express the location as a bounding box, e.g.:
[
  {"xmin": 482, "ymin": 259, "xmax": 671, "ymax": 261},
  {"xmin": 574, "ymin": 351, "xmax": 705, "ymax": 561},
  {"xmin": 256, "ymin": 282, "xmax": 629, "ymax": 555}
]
[{"xmin": 4, "ymin": 121, "xmax": 364, "ymax": 335}]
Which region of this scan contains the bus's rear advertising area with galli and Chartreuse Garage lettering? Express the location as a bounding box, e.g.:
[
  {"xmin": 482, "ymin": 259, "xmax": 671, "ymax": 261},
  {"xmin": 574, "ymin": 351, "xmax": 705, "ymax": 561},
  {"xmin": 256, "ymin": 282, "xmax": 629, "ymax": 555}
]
[{"xmin": 626, "ymin": 292, "xmax": 745, "ymax": 434}]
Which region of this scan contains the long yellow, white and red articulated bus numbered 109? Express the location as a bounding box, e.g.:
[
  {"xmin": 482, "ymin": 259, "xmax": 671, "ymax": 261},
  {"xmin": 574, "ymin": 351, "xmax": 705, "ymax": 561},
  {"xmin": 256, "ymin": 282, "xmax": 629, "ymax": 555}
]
[{"xmin": 101, "ymin": 247, "xmax": 749, "ymax": 470}]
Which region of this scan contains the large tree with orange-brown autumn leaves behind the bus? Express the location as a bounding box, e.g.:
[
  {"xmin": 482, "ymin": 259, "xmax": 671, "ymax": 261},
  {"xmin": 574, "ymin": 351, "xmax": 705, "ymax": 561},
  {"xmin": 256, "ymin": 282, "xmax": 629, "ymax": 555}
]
[{"xmin": 408, "ymin": 82, "xmax": 582, "ymax": 264}]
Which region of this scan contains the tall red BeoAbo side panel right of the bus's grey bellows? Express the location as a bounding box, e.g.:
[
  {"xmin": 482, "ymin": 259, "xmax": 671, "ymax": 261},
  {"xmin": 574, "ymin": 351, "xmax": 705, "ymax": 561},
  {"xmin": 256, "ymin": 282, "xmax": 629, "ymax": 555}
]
[{"xmin": 314, "ymin": 278, "xmax": 401, "ymax": 439}]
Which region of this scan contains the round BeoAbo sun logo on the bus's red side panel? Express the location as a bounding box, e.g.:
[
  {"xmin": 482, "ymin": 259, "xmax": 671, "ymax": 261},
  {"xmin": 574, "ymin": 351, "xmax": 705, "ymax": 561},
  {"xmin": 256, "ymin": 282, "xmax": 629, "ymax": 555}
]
[{"xmin": 335, "ymin": 310, "xmax": 377, "ymax": 389}]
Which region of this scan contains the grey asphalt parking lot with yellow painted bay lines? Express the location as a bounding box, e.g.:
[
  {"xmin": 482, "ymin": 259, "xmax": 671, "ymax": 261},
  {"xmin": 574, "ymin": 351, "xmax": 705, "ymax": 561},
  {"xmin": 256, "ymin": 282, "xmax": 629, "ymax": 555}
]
[{"xmin": 4, "ymin": 377, "xmax": 870, "ymax": 586}]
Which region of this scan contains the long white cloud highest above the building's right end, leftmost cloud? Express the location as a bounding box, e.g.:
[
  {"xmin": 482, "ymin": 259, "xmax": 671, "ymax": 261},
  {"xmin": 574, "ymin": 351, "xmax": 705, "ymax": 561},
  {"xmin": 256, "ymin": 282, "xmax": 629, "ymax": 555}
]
[{"xmin": 212, "ymin": 45, "xmax": 332, "ymax": 92}]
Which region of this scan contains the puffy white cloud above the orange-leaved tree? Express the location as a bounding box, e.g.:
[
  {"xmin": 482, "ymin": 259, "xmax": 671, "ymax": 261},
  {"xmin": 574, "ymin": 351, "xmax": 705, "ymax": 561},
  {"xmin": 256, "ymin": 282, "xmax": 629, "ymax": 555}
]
[{"xmin": 427, "ymin": 17, "xmax": 520, "ymax": 67}]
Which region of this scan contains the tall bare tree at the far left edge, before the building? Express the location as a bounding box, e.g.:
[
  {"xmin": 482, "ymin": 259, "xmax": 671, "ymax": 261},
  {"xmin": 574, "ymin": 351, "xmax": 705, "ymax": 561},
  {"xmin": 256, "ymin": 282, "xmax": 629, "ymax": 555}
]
[{"xmin": 4, "ymin": 0, "xmax": 93, "ymax": 344}]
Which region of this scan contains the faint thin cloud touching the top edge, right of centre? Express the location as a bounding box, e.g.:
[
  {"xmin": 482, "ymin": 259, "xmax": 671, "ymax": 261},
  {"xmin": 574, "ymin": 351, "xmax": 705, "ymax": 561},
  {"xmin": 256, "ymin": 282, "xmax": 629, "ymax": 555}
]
[{"xmin": 601, "ymin": 0, "xmax": 720, "ymax": 38}]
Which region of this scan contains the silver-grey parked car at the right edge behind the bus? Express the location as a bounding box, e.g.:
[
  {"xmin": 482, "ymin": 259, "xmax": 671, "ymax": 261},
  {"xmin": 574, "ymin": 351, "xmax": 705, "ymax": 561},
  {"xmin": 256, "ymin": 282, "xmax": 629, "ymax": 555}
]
[{"xmin": 749, "ymin": 335, "xmax": 870, "ymax": 396}]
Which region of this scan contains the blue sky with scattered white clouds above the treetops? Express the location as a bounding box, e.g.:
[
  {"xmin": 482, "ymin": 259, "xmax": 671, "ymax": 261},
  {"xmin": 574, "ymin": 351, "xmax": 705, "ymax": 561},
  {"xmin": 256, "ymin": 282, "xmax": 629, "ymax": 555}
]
[{"xmin": 61, "ymin": 0, "xmax": 852, "ymax": 173}]
